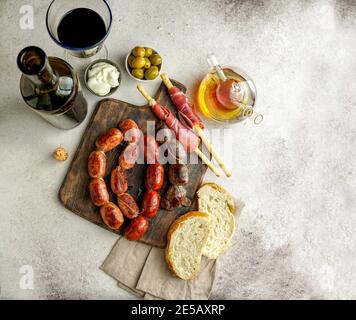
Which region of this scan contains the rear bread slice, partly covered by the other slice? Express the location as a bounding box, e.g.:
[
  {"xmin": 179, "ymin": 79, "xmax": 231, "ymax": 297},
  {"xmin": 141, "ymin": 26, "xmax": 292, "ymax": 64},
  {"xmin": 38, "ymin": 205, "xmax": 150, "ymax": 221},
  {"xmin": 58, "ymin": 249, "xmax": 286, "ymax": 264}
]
[{"xmin": 197, "ymin": 183, "xmax": 235, "ymax": 259}]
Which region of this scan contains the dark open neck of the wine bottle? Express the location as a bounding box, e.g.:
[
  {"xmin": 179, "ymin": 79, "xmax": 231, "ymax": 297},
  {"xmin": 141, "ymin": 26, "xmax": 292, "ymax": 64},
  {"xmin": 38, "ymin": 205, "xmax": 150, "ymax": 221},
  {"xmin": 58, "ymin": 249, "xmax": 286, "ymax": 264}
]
[{"xmin": 17, "ymin": 46, "xmax": 58, "ymax": 91}]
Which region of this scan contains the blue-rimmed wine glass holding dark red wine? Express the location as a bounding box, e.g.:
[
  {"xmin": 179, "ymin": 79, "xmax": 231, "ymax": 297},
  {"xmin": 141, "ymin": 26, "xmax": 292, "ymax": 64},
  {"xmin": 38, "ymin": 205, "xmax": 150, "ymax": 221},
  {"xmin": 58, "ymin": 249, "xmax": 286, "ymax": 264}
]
[{"xmin": 46, "ymin": 0, "xmax": 112, "ymax": 65}]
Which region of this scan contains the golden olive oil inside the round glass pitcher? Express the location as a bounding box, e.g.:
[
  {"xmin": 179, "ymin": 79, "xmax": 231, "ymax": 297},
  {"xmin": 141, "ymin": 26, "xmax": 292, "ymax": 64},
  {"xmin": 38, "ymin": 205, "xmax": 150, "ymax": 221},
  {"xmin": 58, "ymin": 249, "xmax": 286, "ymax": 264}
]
[{"xmin": 196, "ymin": 67, "xmax": 256, "ymax": 122}]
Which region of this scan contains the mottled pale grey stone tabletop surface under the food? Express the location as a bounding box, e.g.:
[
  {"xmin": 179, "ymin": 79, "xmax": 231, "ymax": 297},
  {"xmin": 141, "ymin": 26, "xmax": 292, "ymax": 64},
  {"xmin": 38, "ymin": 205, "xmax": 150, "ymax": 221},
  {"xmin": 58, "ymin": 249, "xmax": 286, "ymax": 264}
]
[{"xmin": 0, "ymin": 0, "xmax": 356, "ymax": 299}]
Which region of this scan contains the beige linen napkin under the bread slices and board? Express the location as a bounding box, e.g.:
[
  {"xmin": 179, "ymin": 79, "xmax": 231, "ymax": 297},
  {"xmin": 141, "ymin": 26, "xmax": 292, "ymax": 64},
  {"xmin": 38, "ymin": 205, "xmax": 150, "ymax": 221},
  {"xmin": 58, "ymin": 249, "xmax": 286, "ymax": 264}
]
[{"xmin": 101, "ymin": 201, "xmax": 244, "ymax": 300}]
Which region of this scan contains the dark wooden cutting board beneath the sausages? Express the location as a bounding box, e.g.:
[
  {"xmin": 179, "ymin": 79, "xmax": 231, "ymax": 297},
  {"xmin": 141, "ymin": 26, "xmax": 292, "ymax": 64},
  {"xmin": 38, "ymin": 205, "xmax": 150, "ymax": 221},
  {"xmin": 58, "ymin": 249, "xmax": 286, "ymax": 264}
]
[{"xmin": 59, "ymin": 80, "xmax": 207, "ymax": 248}]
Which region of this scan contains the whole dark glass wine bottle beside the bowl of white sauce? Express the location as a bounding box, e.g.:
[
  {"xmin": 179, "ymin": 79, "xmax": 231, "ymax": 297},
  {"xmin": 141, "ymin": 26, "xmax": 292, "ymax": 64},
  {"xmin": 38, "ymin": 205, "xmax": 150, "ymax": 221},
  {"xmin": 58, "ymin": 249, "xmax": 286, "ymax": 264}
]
[{"xmin": 17, "ymin": 46, "xmax": 87, "ymax": 129}]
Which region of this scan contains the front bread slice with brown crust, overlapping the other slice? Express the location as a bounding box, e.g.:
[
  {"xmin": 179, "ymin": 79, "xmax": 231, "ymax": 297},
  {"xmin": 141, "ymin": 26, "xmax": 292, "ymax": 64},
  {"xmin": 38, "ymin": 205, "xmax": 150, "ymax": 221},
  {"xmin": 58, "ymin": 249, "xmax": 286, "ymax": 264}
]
[{"xmin": 166, "ymin": 211, "xmax": 210, "ymax": 280}]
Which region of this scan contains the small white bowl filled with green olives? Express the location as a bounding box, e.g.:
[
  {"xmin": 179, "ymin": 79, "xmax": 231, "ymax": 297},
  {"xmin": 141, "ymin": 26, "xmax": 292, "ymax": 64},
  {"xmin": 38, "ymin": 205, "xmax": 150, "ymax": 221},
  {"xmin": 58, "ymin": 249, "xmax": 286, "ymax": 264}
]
[{"xmin": 125, "ymin": 46, "xmax": 162, "ymax": 82}]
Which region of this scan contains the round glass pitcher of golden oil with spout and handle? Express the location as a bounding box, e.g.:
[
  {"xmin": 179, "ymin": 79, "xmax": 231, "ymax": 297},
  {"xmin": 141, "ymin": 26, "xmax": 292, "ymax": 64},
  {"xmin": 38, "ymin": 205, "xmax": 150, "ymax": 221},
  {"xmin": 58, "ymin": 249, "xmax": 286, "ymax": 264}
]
[{"xmin": 196, "ymin": 54, "xmax": 263, "ymax": 124}]
